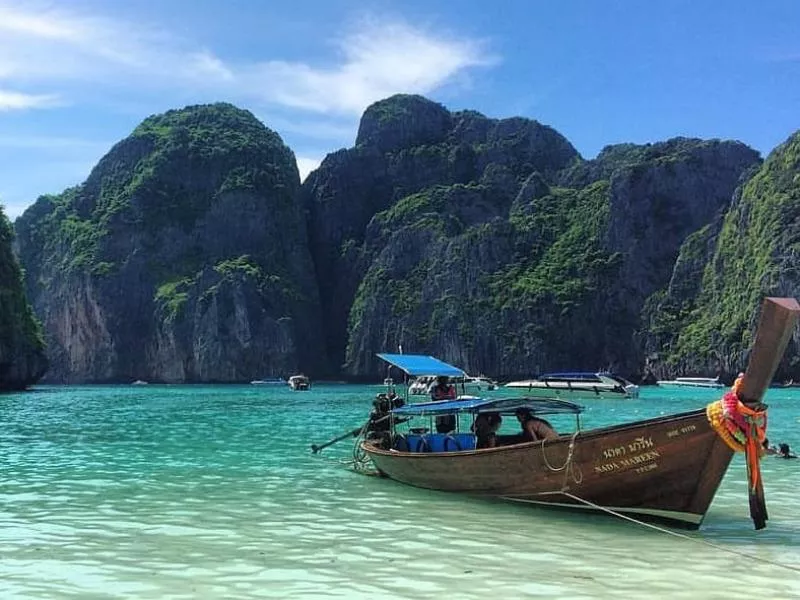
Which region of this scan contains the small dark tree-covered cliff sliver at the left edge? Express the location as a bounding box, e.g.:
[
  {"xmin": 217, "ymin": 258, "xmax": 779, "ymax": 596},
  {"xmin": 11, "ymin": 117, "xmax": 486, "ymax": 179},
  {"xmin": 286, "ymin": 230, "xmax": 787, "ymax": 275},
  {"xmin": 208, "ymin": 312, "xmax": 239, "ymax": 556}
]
[{"xmin": 0, "ymin": 208, "xmax": 48, "ymax": 391}]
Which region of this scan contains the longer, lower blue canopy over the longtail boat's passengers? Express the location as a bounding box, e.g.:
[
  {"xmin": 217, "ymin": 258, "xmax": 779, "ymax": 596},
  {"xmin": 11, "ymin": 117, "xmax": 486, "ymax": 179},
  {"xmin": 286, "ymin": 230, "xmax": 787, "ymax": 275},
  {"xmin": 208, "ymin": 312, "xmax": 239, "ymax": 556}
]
[{"xmin": 392, "ymin": 398, "xmax": 583, "ymax": 417}]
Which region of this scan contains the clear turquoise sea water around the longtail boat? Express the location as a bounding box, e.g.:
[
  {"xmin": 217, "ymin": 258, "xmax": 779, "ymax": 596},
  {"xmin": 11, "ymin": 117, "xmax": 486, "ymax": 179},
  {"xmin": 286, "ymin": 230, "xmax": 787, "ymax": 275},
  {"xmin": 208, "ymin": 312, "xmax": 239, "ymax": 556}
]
[{"xmin": 0, "ymin": 384, "xmax": 800, "ymax": 599}]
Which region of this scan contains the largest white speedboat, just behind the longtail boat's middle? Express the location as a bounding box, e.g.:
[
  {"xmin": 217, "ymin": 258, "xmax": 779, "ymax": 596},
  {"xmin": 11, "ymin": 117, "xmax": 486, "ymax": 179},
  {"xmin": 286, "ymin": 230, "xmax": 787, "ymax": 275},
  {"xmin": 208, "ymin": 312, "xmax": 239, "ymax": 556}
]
[{"xmin": 505, "ymin": 372, "xmax": 639, "ymax": 400}]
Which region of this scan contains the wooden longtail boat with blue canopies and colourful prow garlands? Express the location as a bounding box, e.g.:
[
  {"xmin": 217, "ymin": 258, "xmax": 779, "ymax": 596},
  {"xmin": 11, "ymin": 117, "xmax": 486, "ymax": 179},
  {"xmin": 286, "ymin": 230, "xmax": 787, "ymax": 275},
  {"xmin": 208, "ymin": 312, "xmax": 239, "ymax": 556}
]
[{"xmin": 342, "ymin": 298, "xmax": 800, "ymax": 529}]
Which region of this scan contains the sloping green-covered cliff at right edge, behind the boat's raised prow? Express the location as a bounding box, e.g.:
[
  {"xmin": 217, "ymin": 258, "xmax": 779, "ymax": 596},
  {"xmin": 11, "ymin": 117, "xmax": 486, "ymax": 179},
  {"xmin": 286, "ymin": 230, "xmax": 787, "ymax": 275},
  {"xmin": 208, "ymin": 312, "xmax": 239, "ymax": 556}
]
[{"xmin": 646, "ymin": 132, "xmax": 800, "ymax": 380}]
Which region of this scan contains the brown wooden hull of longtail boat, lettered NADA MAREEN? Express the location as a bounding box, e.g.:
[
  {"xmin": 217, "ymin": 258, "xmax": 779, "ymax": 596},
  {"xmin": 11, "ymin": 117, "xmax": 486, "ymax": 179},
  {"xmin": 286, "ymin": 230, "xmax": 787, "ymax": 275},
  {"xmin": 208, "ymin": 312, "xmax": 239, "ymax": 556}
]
[{"xmin": 362, "ymin": 410, "xmax": 733, "ymax": 529}]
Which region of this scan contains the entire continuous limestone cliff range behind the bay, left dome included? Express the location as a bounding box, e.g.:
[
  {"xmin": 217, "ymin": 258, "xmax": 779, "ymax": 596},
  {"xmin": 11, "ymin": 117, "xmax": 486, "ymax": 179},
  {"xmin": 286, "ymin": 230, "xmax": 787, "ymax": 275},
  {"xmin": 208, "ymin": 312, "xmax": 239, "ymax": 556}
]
[{"xmin": 16, "ymin": 95, "xmax": 788, "ymax": 381}]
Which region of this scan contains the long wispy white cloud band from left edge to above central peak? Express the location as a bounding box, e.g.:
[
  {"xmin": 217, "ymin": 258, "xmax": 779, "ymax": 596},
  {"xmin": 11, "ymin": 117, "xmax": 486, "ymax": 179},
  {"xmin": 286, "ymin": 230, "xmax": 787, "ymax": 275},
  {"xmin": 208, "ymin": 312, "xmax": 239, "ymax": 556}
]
[{"xmin": 0, "ymin": 0, "xmax": 495, "ymax": 115}]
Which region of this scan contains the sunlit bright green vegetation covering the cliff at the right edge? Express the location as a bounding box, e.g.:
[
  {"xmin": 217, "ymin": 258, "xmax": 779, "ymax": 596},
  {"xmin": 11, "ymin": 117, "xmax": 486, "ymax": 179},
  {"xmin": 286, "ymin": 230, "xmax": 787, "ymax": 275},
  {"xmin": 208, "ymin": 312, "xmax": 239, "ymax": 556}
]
[{"xmin": 668, "ymin": 133, "xmax": 800, "ymax": 365}]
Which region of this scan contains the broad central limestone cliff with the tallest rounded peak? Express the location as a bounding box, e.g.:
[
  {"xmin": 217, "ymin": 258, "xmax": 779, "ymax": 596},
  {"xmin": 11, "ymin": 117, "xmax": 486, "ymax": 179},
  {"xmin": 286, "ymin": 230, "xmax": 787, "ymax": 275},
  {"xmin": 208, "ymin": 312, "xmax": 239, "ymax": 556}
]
[{"xmin": 303, "ymin": 96, "xmax": 759, "ymax": 377}]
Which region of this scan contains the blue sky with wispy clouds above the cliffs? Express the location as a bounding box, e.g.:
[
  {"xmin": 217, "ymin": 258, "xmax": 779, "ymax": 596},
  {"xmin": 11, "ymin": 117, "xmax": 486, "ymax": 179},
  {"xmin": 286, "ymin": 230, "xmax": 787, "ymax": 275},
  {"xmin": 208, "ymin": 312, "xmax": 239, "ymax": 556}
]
[{"xmin": 0, "ymin": 0, "xmax": 800, "ymax": 220}]
